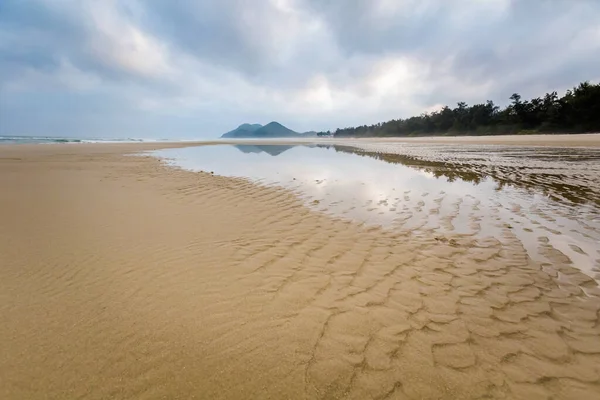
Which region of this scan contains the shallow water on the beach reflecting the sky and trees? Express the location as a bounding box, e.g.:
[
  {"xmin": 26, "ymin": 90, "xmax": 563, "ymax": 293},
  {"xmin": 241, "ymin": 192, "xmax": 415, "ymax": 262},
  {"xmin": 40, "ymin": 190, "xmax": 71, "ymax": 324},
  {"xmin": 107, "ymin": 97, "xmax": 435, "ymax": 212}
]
[{"xmin": 154, "ymin": 143, "xmax": 600, "ymax": 280}]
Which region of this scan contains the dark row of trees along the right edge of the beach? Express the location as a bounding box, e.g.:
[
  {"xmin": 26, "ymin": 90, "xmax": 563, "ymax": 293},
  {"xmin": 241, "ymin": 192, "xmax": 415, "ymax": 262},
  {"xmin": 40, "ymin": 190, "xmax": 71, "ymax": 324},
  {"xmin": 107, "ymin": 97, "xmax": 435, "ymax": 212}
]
[{"xmin": 333, "ymin": 82, "xmax": 600, "ymax": 137}]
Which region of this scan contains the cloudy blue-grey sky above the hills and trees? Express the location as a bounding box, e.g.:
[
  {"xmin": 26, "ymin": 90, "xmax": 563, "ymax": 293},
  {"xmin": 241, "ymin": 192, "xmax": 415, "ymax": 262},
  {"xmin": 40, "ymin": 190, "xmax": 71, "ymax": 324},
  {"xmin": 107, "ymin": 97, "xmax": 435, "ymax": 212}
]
[{"xmin": 0, "ymin": 0, "xmax": 600, "ymax": 138}]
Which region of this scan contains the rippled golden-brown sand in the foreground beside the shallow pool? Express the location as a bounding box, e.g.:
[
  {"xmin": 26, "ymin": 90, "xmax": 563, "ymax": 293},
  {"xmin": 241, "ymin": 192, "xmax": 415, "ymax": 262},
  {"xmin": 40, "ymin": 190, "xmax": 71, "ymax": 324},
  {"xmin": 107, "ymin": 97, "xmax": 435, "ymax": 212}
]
[{"xmin": 0, "ymin": 139, "xmax": 600, "ymax": 399}]
